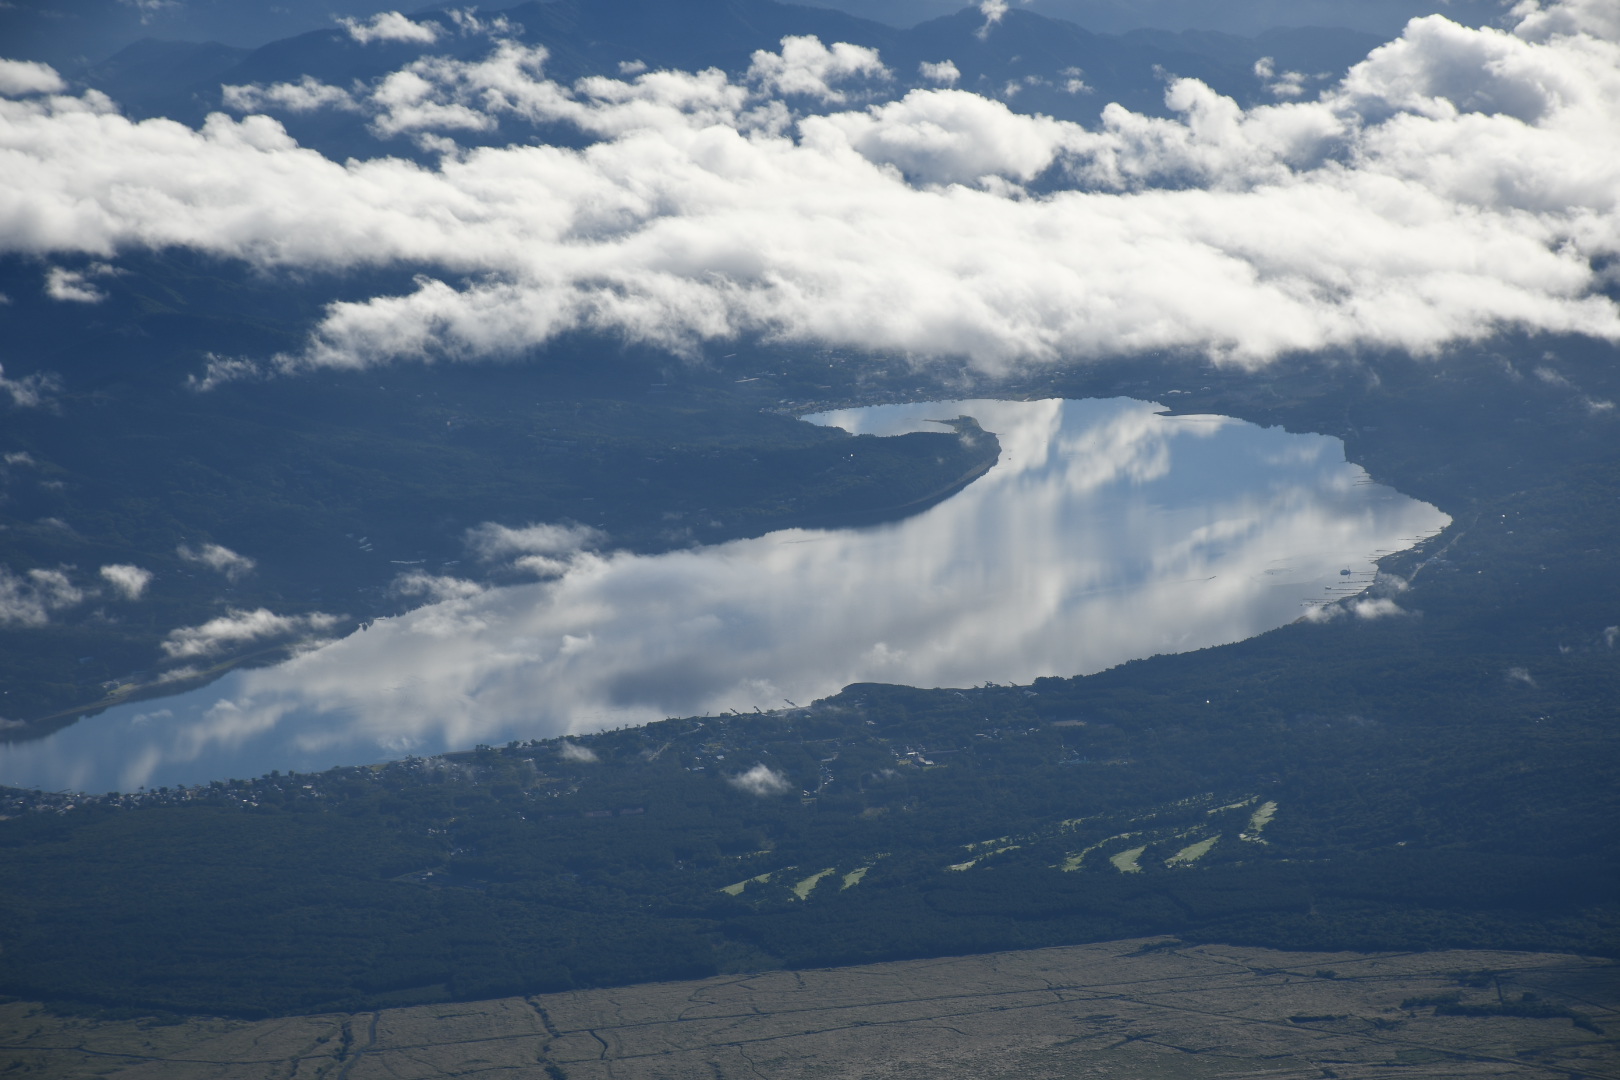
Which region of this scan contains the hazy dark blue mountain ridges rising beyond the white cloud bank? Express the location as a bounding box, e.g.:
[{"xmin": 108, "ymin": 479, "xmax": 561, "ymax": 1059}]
[{"xmin": 59, "ymin": 0, "xmax": 1382, "ymax": 155}]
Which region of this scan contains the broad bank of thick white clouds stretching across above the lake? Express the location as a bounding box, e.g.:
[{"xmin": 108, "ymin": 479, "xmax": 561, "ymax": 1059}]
[{"xmin": 0, "ymin": 0, "xmax": 1620, "ymax": 377}]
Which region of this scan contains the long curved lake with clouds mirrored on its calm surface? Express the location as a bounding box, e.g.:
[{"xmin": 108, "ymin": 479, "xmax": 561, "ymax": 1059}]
[{"xmin": 0, "ymin": 398, "xmax": 1450, "ymax": 792}]
